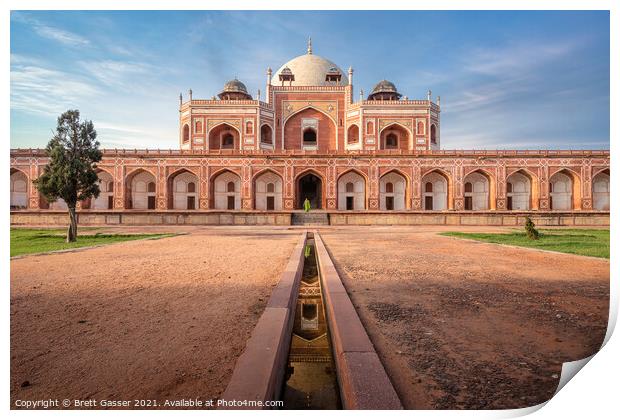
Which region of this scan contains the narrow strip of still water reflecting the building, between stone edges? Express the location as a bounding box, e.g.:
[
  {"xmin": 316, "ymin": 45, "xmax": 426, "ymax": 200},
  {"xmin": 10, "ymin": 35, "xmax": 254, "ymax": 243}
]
[{"xmin": 282, "ymin": 239, "xmax": 341, "ymax": 409}]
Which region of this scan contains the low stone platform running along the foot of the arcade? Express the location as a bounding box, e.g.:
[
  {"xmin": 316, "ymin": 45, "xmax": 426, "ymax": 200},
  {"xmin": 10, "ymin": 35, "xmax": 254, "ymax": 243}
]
[{"xmin": 11, "ymin": 210, "xmax": 609, "ymax": 226}]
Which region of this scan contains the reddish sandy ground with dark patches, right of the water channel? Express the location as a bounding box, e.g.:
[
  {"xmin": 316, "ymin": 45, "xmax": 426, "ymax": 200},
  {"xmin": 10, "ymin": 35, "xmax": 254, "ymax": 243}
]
[{"xmin": 321, "ymin": 227, "xmax": 609, "ymax": 409}]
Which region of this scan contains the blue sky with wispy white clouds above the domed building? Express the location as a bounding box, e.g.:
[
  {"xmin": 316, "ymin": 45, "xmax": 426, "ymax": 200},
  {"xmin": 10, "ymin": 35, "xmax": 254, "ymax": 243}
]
[{"xmin": 11, "ymin": 11, "xmax": 609, "ymax": 149}]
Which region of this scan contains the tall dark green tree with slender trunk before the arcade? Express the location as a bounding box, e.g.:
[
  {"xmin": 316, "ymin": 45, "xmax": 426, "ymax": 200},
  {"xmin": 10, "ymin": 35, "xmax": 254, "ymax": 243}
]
[{"xmin": 33, "ymin": 110, "xmax": 101, "ymax": 242}]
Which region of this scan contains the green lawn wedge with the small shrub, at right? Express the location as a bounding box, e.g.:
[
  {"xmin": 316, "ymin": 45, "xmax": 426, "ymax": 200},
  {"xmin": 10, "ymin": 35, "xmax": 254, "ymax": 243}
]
[{"xmin": 441, "ymin": 229, "xmax": 609, "ymax": 259}]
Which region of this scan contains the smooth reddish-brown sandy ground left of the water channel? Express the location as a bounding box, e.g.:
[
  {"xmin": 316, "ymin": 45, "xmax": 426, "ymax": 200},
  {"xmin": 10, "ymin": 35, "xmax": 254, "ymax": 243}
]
[{"xmin": 11, "ymin": 227, "xmax": 298, "ymax": 407}]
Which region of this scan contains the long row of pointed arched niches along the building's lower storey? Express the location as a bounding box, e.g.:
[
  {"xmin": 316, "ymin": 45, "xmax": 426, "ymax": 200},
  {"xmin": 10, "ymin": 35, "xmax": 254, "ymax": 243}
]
[{"xmin": 10, "ymin": 162, "xmax": 610, "ymax": 211}]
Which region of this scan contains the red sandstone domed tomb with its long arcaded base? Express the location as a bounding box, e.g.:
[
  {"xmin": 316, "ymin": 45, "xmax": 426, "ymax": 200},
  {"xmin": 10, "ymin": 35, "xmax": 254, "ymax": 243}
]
[{"xmin": 10, "ymin": 43, "xmax": 610, "ymax": 224}]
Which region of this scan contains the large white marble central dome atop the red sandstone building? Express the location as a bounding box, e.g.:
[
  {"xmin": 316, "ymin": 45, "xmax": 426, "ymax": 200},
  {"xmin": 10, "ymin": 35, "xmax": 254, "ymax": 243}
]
[{"xmin": 271, "ymin": 52, "xmax": 349, "ymax": 86}]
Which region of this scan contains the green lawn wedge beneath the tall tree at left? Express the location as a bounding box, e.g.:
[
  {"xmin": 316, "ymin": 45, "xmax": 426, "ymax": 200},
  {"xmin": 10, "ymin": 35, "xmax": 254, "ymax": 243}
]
[{"xmin": 11, "ymin": 228, "xmax": 174, "ymax": 257}]
